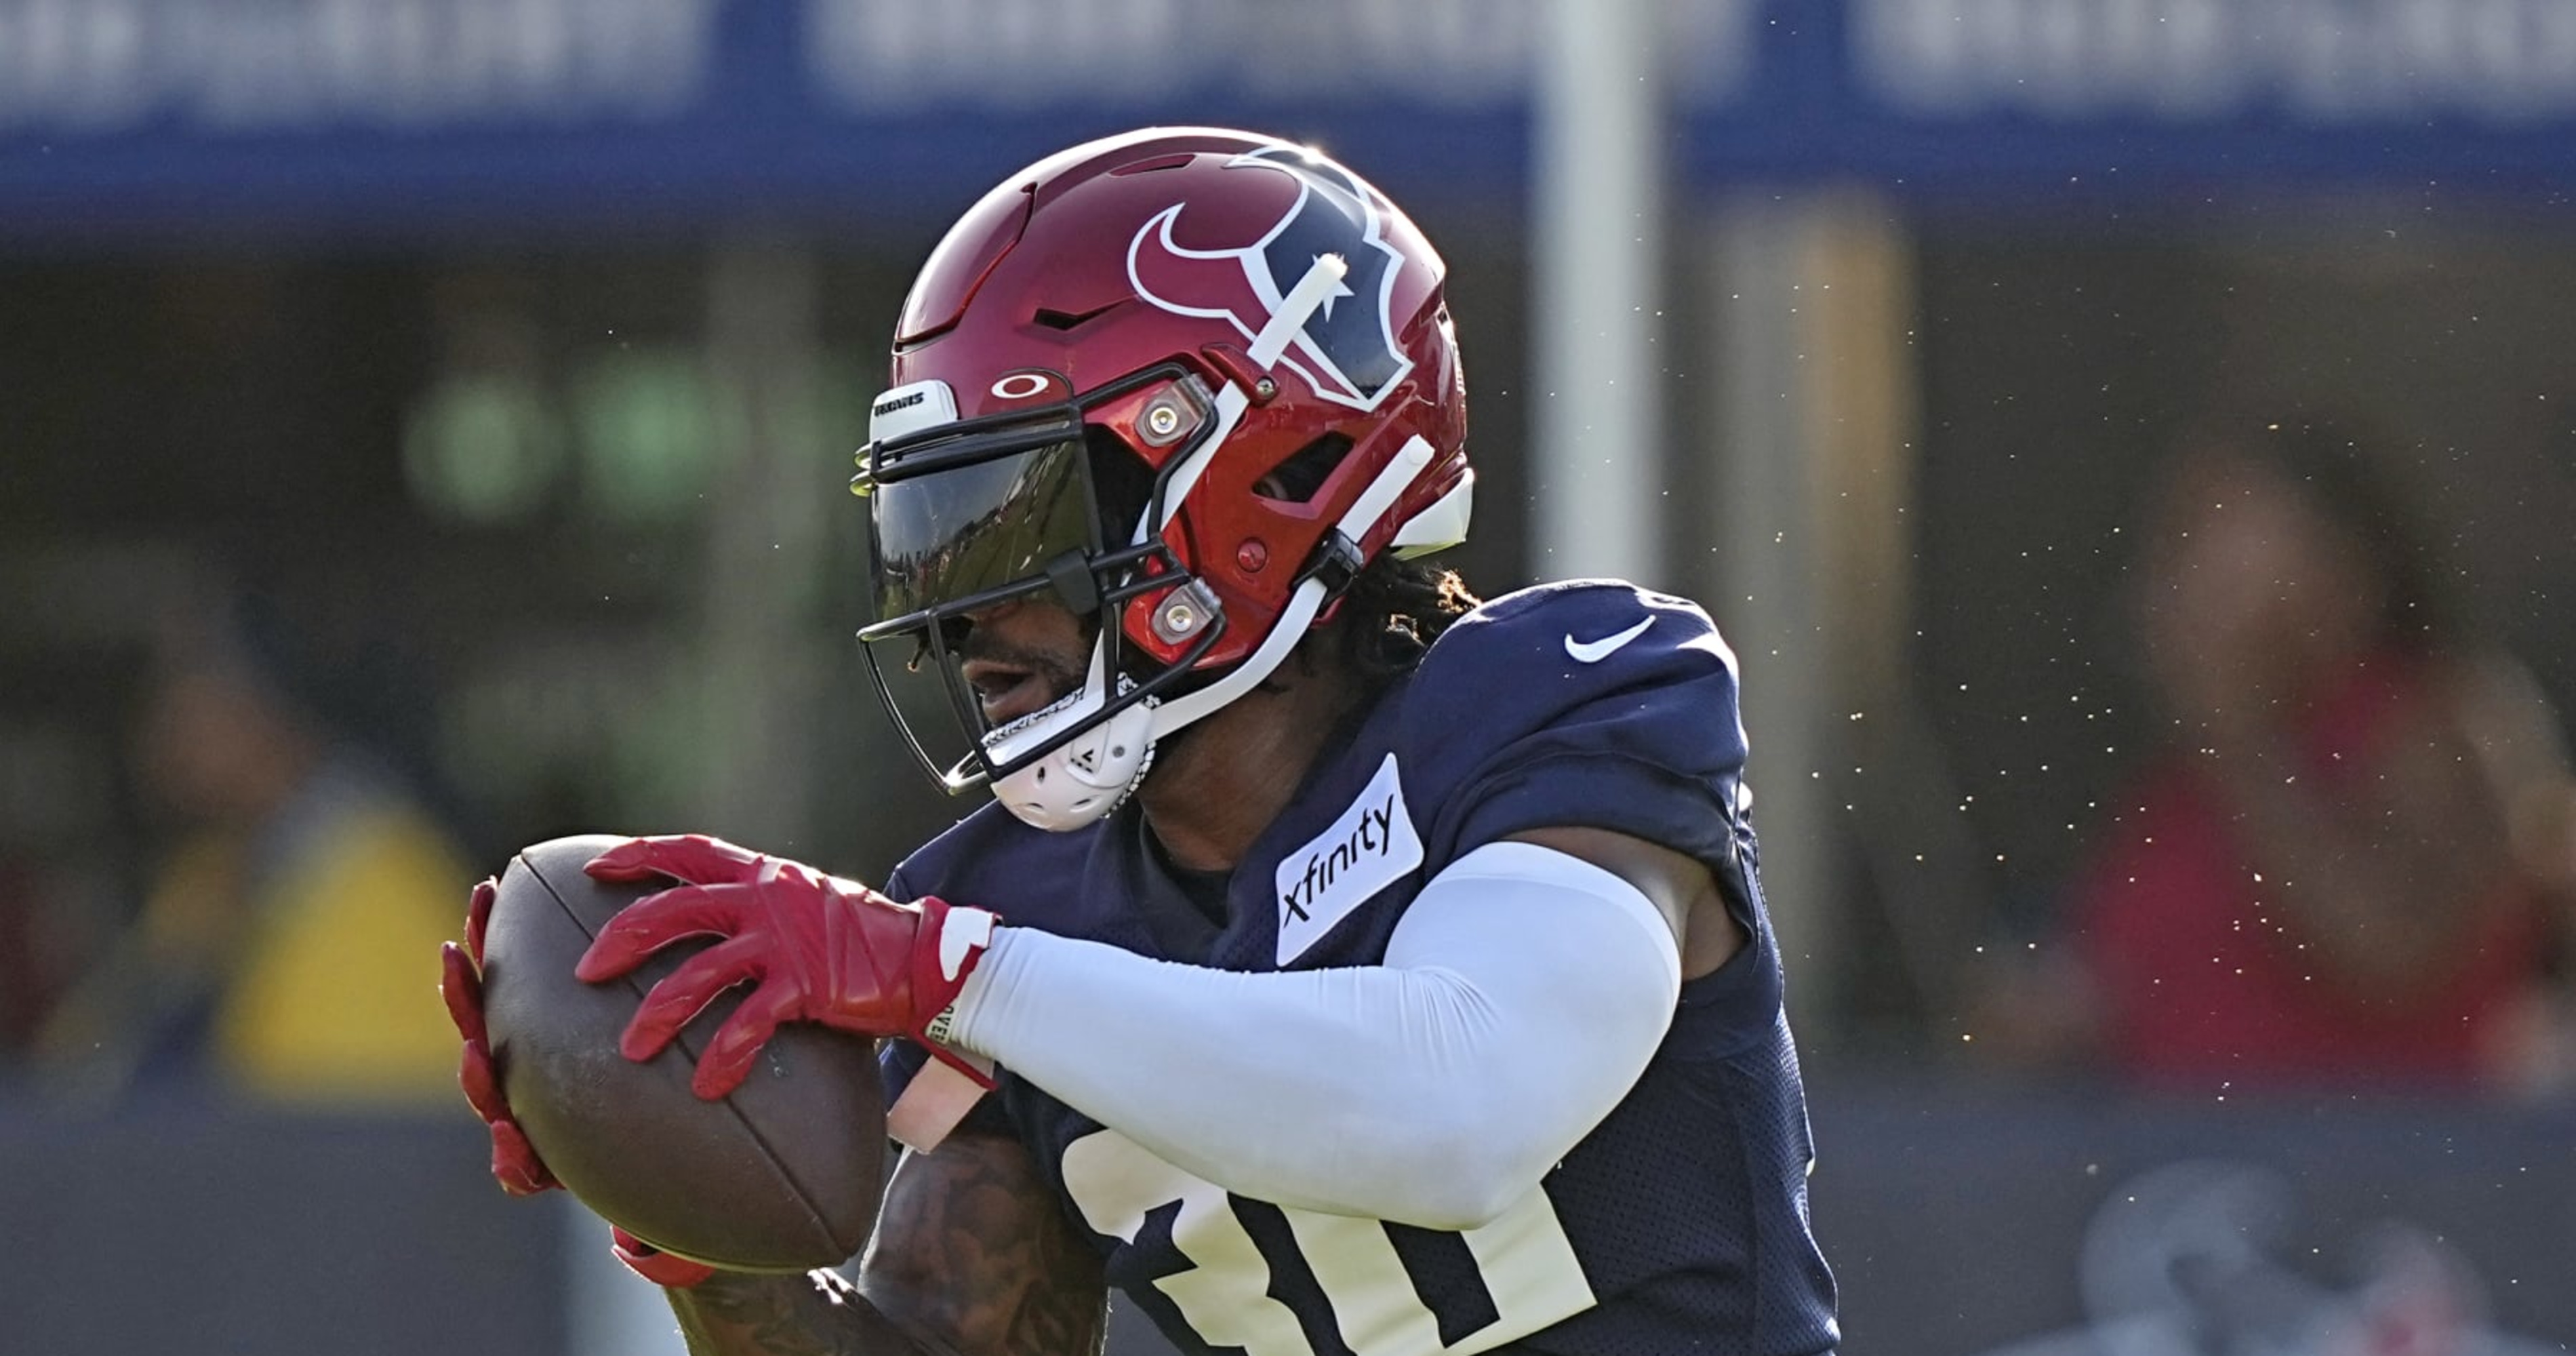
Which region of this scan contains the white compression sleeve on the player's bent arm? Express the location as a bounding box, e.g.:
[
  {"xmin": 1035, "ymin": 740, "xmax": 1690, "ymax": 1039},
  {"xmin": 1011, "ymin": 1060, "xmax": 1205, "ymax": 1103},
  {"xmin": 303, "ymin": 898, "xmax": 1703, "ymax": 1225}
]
[{"xmin": 953, "ymin": 843, "xmax": 1682, "ymax": 1230}]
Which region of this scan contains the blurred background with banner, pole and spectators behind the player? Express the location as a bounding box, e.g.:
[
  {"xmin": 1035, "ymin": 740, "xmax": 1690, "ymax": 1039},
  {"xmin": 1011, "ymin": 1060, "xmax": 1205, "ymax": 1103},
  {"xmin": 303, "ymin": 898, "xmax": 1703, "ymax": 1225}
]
[{"xmin": 0, "ymin": 0, "xmax": 2576, "ymax": 1356}]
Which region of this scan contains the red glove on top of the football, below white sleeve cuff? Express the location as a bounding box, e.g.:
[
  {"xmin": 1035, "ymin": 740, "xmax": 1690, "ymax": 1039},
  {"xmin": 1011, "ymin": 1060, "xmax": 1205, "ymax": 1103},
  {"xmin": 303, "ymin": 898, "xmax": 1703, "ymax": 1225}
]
[{"xmin": 574, "ymin": 833, "xmax": 994, "ymax": 1098}]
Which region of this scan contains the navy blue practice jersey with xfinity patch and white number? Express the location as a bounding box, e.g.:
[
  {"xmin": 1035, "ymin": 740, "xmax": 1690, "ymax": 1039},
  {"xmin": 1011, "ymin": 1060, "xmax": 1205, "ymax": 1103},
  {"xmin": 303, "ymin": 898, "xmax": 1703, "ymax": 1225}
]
[{"xmin": 886, "ymin": 582, "xmax": 1836, "ymax": 1356}]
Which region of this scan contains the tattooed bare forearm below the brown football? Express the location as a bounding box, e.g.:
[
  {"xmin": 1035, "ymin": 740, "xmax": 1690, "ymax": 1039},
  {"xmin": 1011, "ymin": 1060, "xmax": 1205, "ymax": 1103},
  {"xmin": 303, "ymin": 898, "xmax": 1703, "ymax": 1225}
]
[{"xmin": 670, "ymin": 1134, "xmax": 1108, "ymax": 1356}]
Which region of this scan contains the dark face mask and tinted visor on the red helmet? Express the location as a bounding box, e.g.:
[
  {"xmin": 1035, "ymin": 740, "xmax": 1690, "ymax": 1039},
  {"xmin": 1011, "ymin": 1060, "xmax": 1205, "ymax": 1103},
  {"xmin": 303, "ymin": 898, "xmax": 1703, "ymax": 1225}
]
[{"xmin": 856, "ymin": 366, "xmax": 1224, "ymax": 791}]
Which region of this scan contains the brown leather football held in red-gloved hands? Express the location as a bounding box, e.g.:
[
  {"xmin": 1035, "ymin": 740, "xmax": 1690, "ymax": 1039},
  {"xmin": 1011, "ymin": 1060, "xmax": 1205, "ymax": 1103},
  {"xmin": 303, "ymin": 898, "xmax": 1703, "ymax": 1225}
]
[{"xmin": 484, "ymin": 835, "xmax": 886, "ymax": 1271}]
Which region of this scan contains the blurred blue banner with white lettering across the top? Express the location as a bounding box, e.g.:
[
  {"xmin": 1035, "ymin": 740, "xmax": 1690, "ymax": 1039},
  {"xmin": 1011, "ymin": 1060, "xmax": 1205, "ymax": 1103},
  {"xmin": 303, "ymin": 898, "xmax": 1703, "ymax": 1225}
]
[{"xmin": 0, "ymin": 0, "xmax": 2576, "ymax": 232}]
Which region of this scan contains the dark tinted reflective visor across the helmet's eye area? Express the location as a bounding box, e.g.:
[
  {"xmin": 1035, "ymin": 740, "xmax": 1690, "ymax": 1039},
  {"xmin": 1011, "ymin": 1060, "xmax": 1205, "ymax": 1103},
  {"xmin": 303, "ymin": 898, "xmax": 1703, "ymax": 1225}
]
[{"xmin": 868, "ymin": 436, "xmax": 1098, "ymax": 621}]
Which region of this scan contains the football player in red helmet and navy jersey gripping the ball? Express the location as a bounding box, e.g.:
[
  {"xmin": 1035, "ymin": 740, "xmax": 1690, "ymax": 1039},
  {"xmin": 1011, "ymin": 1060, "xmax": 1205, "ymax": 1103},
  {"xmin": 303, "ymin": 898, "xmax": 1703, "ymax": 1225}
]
[{"xmin": 448, "ymin": 129, "xmax": 1836, "ymax": 1356}]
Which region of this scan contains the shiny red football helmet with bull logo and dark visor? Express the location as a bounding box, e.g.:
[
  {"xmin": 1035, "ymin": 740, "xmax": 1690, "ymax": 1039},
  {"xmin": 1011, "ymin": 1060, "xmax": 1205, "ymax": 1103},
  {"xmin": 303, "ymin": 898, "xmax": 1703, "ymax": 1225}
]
[{"xmin": 853, "ymin": 129, "xmax": 1474, "ymax": 828}]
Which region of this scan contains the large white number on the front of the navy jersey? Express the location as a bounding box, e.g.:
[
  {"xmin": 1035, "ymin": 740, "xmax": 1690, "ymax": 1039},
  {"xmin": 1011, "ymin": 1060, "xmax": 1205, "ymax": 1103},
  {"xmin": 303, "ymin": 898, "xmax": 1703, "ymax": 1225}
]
[{"xmin": 1064, "ymin": 1129, "xmax": 1592, "ymax": 1356}]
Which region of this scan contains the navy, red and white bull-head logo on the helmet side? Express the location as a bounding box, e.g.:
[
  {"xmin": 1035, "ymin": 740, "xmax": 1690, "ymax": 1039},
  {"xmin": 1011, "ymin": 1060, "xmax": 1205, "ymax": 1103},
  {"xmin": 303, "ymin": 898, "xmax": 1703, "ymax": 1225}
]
[{"xmin": 1128, "ymin": 147, "xmax": 1414, "ymax": 410}]
